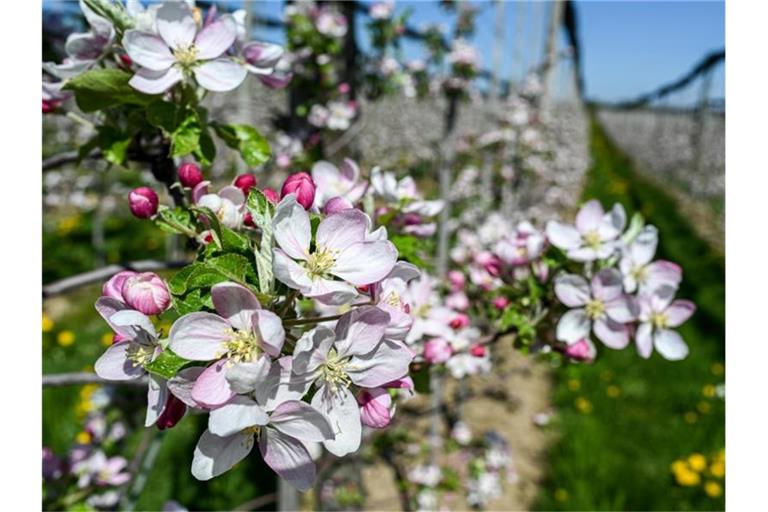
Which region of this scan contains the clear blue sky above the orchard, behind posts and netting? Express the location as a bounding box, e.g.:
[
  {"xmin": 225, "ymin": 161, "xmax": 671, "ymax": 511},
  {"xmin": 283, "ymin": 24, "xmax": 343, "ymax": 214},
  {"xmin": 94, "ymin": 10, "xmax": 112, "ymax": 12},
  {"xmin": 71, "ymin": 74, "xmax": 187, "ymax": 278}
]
[{"xmin": 44, "ymin": 0, "xmax": 725, "ymax": 104}]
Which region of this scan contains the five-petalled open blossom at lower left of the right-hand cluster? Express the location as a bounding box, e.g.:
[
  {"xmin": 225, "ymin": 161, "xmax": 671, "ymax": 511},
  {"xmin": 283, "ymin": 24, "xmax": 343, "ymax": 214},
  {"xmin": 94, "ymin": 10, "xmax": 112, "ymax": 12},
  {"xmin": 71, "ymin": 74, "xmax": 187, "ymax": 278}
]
[{"xmin": 555, "ymin": 268, "xmax": 637, "ymax": 349}]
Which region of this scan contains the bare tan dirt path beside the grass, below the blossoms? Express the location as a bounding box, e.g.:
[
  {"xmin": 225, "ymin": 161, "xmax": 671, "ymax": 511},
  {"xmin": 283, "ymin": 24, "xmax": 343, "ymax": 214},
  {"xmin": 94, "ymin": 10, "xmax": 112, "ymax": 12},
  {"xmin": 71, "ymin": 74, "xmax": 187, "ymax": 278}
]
[{"xmin": 363, "ymin": 342, "xmax": 552, "ymax": 510}]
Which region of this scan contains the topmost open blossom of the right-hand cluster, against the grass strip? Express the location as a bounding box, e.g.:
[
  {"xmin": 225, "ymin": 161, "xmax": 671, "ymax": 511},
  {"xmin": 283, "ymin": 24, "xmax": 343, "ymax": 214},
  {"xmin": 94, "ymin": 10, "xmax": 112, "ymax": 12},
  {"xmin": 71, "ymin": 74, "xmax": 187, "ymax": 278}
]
[{"xmin": 546, "ymin": 200, "xmax": 627, "ymax": 261}]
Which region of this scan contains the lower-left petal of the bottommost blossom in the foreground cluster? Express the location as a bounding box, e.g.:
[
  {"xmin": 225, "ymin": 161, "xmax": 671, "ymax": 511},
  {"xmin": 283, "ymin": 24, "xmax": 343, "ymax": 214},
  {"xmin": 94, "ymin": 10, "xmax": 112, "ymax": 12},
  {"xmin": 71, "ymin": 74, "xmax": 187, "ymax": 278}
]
[{"xmin": 192, "ymin": 430, "xmax": 253, "ymax": 480}]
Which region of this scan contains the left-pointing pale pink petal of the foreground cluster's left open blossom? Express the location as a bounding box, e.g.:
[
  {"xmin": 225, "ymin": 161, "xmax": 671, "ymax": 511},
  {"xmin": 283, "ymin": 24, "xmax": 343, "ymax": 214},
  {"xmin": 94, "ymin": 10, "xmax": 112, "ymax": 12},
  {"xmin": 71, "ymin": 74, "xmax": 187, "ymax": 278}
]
[{"xmin": 168, "ymin": 312, "xmax": 231, "ymax": 361}]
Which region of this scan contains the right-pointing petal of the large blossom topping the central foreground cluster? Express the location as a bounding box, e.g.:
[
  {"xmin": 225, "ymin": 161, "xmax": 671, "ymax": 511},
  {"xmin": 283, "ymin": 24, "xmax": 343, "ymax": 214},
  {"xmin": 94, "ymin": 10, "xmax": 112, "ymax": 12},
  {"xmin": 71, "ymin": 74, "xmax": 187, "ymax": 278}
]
[{"xmin": 331, "ymin": 241, "xmax": 397, "ymax": 286}]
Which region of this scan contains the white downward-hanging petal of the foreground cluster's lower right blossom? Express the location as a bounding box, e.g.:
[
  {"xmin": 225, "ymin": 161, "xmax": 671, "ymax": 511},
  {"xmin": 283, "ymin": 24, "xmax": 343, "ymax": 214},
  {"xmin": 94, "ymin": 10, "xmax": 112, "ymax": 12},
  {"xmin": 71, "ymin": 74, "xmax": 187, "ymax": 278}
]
[{"xmin": 312, "ymin": 386, "xmax": 363, "ymax": 457}]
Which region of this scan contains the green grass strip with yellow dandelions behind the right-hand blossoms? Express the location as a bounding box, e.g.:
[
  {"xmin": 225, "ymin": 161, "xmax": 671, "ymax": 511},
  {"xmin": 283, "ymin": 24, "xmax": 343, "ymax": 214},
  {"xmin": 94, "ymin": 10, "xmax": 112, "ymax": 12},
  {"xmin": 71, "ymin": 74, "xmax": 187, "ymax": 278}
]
[{"xmin": 536, "ymin": 120, "xmax": 725, "ymax": 510}]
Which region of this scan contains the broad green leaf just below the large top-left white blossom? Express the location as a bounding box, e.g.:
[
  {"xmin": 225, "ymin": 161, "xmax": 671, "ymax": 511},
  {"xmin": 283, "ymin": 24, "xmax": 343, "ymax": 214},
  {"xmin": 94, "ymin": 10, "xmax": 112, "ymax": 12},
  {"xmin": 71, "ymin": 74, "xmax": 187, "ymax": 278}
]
[{"xmin": 63, "ymin": 68, "xmax": 157, "ymax": 112}]
